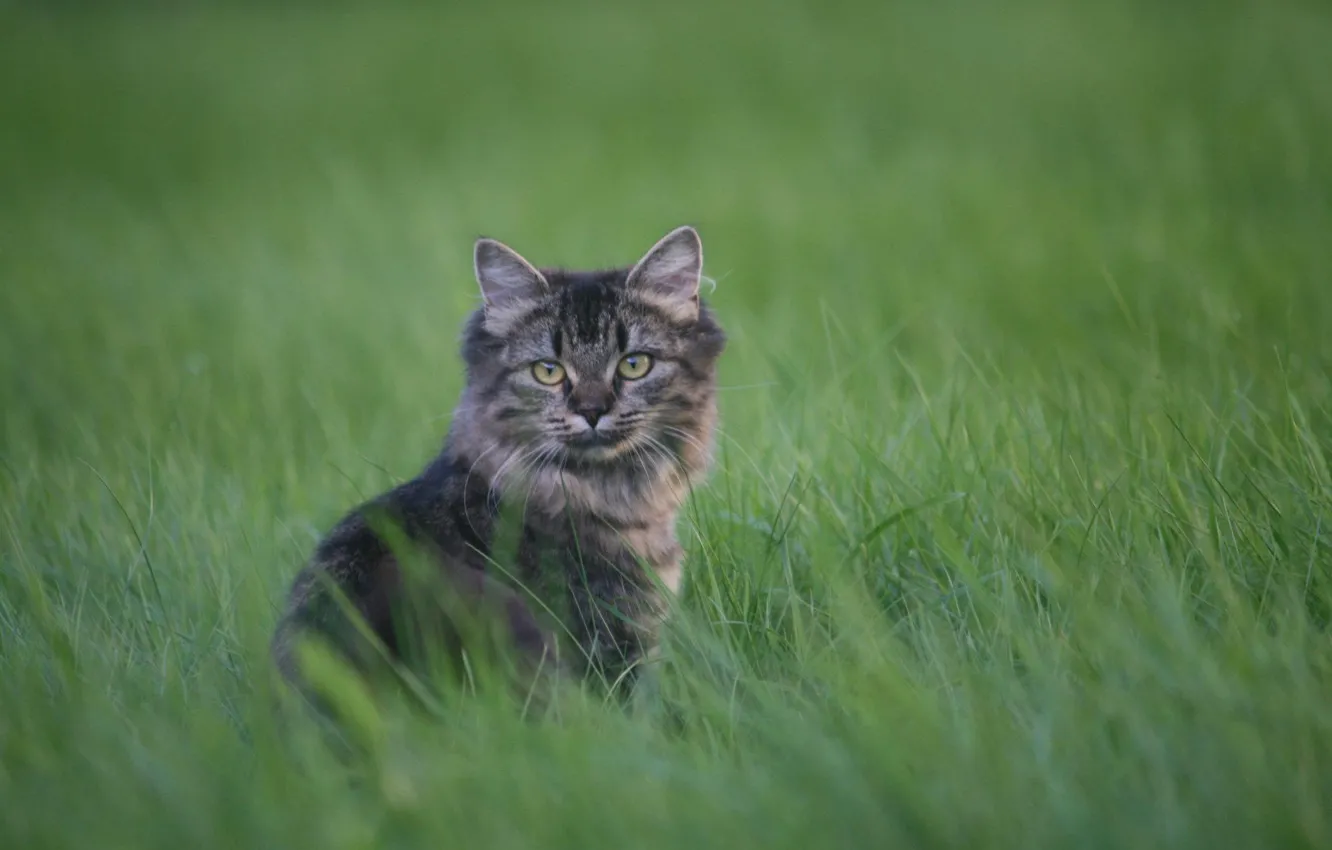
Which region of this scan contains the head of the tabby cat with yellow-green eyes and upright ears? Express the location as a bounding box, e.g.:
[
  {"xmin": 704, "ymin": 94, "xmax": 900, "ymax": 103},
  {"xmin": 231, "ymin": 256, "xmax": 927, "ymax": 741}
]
[{"xmin": 462, "ymin": 226, "xmax": 726, "ymax": 484}]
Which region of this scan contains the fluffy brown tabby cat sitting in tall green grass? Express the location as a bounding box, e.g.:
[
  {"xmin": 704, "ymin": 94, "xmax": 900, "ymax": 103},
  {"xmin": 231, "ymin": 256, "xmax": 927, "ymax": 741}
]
[{"xmin": 272, "ymin": 226, "xmax": 726, "ymax": 708}]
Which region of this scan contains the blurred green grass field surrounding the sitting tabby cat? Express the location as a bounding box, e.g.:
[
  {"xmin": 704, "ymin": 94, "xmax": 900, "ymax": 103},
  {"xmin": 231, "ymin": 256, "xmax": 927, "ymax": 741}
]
[{"xmin": 0, "ymin": 0, "xmax": 1332, "ymax": 850}]
